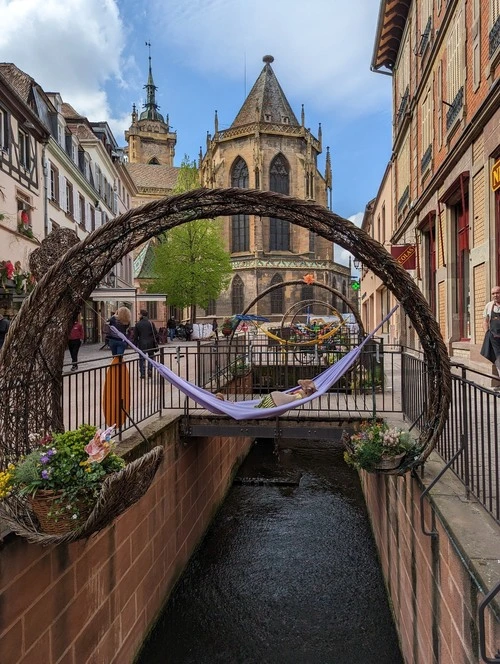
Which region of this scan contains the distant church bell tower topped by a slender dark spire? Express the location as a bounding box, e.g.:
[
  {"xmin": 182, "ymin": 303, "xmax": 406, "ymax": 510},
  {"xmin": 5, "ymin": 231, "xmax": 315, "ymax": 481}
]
[{"xmin": 125, "ymin": 53, "xmax": 177, "ymax": 166}]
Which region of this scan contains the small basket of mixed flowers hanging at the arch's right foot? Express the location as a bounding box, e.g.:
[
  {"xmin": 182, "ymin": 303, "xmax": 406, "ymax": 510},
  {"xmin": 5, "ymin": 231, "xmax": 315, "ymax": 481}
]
[{"xmin": 343, "ymin": 420, "xmax": 415, "ymax": 471}]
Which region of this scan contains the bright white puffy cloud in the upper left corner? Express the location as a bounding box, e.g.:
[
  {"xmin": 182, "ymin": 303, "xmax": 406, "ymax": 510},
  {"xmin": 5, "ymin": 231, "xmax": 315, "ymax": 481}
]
[{"xmin": 0, "ymin": 0, "xmax": 125, "ymax": 131}]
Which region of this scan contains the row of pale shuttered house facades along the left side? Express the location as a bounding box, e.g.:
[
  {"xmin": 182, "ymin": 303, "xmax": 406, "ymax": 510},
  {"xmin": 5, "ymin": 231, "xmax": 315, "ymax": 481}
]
[{"xmin": 0, "ymin": 63, "xmax": 134, "ymax": 341}]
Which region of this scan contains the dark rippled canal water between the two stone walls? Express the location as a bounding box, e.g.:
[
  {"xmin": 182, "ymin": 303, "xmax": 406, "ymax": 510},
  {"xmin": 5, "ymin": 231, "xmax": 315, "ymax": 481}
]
[{"xmin": 137, "ymin": 441, "xmax": 403, "ymax": 664}]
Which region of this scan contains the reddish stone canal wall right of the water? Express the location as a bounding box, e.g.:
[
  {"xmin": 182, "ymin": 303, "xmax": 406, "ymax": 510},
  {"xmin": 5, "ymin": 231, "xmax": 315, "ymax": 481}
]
[{"xmin": 361, "ymin": 453, "xmax": 500, "ymax": 664}]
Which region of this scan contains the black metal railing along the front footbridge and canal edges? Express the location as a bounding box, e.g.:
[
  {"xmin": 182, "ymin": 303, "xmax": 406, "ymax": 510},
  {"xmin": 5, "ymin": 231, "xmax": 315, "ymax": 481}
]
[{"xmin": 63, "ymin": 337, "xmax": 500, "ymax": 521}]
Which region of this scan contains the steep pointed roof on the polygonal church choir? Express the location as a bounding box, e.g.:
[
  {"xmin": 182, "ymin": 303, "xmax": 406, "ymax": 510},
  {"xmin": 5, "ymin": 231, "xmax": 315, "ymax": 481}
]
[{"xmin": 231, "ymin": 55, "xmax": 300, "ymax": 127}]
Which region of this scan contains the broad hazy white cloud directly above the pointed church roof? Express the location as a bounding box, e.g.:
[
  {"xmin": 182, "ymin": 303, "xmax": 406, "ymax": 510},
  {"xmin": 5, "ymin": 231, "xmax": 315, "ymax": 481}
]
[{"xmin": 154, "ymin": 0, "xmax": 390, "ymax": 115}]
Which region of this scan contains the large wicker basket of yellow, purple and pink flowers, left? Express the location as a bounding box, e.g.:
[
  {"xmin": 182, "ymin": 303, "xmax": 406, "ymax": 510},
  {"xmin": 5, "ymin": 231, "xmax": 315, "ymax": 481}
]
[{"xmin": 0, "ymin": 424, "xmax": 125, "ymax": 534}]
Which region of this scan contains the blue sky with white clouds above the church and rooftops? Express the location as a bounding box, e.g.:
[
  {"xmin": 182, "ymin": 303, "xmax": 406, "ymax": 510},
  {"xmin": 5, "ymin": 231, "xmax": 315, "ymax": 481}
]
[{"xmin": 0, "ymin": 0, "xmax": 392, "ymax": 264}]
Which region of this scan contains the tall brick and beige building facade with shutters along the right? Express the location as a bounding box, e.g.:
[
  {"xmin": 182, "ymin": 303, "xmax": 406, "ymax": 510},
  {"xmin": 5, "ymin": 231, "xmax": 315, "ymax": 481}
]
[{"xmin": 372, "ymin": 0, "xmax": 500, "ymax": 370}]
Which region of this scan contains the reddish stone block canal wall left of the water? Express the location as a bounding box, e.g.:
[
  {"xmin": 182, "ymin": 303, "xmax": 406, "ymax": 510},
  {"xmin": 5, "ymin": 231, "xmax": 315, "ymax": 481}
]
[{"xmin": 0, "ymin": 418, "xmax": 251, "ymax": 664}]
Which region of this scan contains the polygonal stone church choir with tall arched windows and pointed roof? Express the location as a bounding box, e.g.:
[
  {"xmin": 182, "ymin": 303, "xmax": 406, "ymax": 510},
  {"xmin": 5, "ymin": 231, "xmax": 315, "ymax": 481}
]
[{"xmin": 200, "ymin": 55, "xmax": 350, "ymax": 320}]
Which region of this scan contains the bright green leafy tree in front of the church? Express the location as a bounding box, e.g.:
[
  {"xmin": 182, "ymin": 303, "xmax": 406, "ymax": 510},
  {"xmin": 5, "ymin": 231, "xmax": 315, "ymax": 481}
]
[{"xmin": 150, "ymin": 157, "xmax": 232, "ymax": 322}]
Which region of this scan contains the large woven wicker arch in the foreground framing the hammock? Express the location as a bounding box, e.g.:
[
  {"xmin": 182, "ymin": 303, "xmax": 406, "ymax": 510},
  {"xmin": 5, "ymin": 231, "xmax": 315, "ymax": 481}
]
[{"xmin": 0, "ymin": 189, "xmax": 451, "ymax": 474}]
